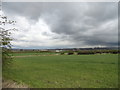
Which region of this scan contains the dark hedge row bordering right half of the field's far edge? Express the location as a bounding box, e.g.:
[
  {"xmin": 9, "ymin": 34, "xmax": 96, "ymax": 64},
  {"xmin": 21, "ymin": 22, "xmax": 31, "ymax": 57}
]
[{"xmin": 61, "ymin": 50, "xmax": 120, "ymax": 55}]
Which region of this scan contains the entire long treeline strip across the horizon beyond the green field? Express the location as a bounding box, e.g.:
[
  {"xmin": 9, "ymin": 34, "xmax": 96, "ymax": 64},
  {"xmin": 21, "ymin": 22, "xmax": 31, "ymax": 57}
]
[{"xmin": 13, "ymin": 50, "xmax": 120, "ymax": 55}]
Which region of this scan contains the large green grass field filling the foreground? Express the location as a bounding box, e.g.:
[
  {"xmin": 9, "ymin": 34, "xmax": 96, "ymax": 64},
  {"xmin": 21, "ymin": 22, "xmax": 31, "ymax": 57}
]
[{"xmin": 3, "ymin": 54, "xmax": 118, "ymax": 88}]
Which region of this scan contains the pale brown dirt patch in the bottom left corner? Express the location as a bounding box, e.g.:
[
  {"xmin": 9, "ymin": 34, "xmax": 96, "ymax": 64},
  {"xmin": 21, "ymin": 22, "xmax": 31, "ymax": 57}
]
[{"xmin": 2, "ymin": 80, "xmax": 28, "ymax": 88}]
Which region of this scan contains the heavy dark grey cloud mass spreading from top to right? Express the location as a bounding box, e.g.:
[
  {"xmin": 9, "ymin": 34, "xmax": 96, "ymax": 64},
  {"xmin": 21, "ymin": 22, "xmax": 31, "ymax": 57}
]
[{"xmin": 3, "ymin": 2, "xmax": 118, "ymax": 46}]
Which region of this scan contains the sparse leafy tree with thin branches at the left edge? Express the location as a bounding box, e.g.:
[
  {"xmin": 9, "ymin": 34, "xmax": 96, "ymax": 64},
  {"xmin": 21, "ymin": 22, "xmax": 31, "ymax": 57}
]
[{"xmin": 0, "ymin": 15, "xmax": 16, "ymax": 67}]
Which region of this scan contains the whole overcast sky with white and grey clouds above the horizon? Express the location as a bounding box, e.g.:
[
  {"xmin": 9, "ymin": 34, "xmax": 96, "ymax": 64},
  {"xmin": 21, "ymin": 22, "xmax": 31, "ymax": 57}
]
[{"xmin": 2, "ymin": 2, "xmax": 118, "ymax": 49}]
